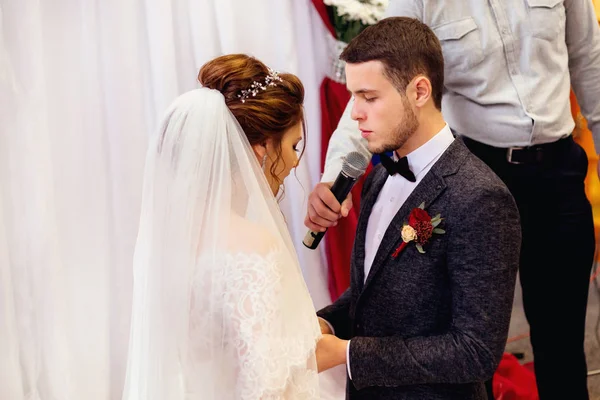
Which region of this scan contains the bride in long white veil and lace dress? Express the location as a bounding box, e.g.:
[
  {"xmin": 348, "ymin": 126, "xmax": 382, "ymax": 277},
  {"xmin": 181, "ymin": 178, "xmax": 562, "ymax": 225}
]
[{"xmin": 123, "ymin": 55, "xmax": 321, "ymax": 400}]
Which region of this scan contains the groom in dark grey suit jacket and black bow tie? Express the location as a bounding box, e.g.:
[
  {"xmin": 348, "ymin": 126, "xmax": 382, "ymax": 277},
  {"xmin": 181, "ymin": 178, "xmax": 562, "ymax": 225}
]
[{"xmin": 309, "ymin": 17, "xmax": 521, "ymax": 400}]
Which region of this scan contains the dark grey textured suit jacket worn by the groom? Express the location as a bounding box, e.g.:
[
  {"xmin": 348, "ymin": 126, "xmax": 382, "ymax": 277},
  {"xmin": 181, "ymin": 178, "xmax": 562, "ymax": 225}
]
[{"xmin": 318, "ymin": 139, "xmax": 521, "ymax": 400}]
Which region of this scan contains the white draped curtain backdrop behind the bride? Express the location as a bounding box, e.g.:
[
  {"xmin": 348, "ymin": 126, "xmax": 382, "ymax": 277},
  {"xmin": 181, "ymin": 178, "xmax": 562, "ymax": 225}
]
[{"xmin": 0, "ymin": 0, "xmax": 345, "ymax": 400}]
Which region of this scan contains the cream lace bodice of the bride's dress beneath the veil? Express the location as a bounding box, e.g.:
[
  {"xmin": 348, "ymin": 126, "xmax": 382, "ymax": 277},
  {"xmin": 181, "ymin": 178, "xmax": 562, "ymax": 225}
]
[{"xmin": 185, "ymin": 251, "xmax": 319, "ymax": 400}]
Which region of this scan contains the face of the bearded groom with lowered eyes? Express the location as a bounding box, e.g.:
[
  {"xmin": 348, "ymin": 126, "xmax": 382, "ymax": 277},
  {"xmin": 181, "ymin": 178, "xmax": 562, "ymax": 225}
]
[{"xmin": 346, "ymin": 61, "xmax": 419, "ymax": 153}]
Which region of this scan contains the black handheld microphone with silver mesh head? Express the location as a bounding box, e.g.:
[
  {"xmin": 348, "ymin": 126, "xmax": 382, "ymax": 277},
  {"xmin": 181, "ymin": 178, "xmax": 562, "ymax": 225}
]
[{"xmin": 302, "ymin": 151, "xmax": 369, "ymax": 250}]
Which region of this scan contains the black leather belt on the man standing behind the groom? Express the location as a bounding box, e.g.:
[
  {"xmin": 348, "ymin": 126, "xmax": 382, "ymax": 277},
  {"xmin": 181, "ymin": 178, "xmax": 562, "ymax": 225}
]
[{"xmin": 463, "ymin": 136, "xmax": 573, "ymax": 165}]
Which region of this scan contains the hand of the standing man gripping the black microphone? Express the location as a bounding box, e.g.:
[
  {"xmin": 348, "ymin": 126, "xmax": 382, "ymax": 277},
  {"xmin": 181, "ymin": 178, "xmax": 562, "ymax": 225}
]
[{"xmin": 304, "ymin": 182, "xmax": 352, "ymax": 232}]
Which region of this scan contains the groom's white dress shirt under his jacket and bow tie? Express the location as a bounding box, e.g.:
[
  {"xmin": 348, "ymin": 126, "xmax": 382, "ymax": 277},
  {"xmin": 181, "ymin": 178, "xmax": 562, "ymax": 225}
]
[{"xmin": 342, "ymin": 125, "xmax": 454, "ymax": 379}]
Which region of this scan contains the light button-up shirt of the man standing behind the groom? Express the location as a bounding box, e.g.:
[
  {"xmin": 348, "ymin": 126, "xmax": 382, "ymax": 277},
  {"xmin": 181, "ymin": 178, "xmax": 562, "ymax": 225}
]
[{"xmin": 322, "ymin": 0, "xmax": 600, "ymax": 182}]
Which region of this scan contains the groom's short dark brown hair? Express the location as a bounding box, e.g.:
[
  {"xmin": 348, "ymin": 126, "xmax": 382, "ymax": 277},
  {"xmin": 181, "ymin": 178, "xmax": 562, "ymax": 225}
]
[{"xmin": 340, "ymin": 17, "xmax": 444, "ymax": 110}]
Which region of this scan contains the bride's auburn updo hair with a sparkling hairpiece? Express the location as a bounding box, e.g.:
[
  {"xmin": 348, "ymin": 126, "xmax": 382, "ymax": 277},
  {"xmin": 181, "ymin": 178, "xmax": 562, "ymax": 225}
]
[{"xmin": 198, "ymin": 54, "xmax": 304, "ymax": 188}]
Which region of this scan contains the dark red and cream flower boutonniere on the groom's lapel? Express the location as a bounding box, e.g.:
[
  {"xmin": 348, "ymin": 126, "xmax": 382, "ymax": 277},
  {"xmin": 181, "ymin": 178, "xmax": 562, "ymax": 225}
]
[{"xmin": 392, "ymin": 203, "xmax": 446, "ymax": 258}]
